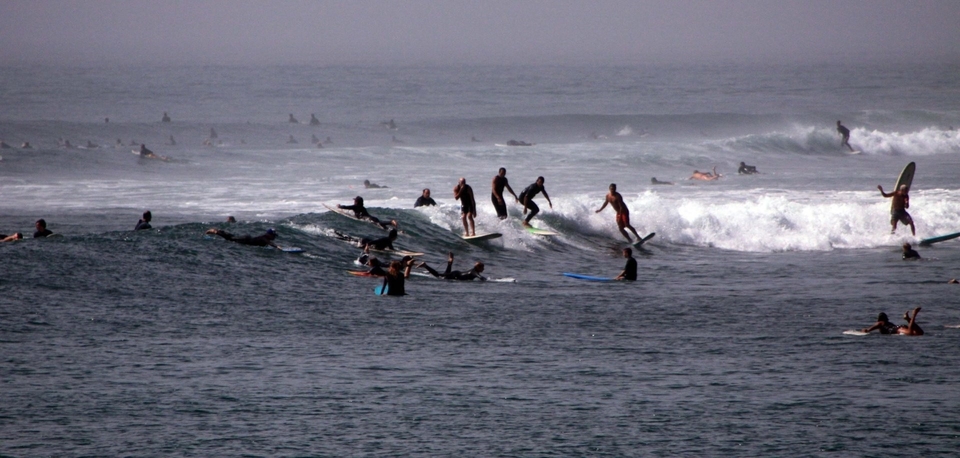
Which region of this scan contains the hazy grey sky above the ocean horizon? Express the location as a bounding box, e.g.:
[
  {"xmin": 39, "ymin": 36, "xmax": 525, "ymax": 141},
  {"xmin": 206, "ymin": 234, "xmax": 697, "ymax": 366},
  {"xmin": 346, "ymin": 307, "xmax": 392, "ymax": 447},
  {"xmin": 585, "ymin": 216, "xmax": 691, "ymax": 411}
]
[{"xmin": 0, "ymin": 0, "xmax": 960, "ymax": 65}]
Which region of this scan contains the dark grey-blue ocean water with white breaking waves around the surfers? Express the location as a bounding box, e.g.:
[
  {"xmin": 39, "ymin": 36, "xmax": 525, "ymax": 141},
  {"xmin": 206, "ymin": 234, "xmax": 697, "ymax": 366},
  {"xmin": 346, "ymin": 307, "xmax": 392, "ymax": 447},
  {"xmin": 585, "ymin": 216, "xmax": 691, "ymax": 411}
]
[{"xmin": 0, "ymin": 65, "xmax": 960, "ymax": 456}]
